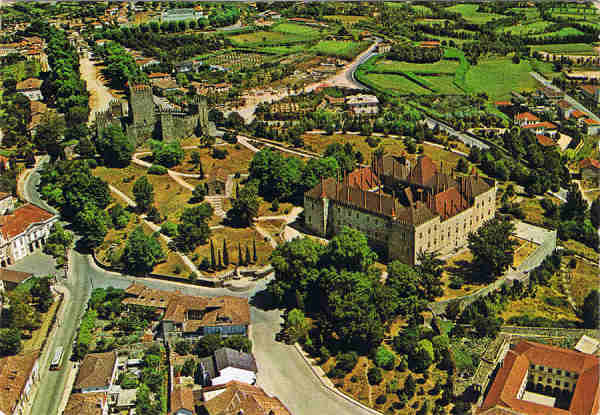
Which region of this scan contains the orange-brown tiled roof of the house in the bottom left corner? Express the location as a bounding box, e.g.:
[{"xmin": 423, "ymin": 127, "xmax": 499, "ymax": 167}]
[{"xmin": 0, "ymin": 350, "xmax": 40, "ymax": 414}]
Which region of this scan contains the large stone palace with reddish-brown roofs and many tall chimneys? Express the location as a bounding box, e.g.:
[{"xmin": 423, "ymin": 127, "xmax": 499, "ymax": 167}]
[{"xmin": 304, "ymin": 156, "xmax": 496, "ymax": 265}]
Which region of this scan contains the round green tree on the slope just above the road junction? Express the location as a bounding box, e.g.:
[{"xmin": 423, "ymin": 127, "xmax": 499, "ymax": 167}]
[{"xmin": 123, "ymin": 226, "xmax": 166, "ymax": 275}]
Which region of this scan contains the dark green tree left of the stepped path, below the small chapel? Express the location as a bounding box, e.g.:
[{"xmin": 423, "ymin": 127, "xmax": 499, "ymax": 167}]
[{"xmin": 174, "ymin": 203, "xmax": 213, "ymax": 251}]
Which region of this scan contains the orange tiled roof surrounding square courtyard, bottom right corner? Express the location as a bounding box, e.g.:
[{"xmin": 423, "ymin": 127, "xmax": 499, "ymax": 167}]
[{"xmin": 480, "ymin": 341, "xmax": 600, "ymax": 415}]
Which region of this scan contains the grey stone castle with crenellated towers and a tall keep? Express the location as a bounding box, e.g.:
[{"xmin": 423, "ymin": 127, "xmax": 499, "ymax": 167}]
[{"xmin": 96, "ymin": 85, "xmax": 208, "ymax": 145}]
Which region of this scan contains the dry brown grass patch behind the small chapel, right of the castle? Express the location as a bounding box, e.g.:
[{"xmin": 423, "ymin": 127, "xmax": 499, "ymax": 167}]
[{"xmin": 173, "ymin": 144, "xmax": 254, "ymax": 176}]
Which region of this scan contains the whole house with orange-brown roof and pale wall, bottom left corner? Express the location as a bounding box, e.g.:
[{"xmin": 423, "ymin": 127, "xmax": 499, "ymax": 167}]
[{"xmin": 0, "ymin": 350, "xmax": 40, "ymax": 415}]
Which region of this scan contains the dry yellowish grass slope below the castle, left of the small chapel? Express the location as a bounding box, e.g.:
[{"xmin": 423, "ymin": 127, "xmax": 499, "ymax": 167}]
[{"xmin": 94, "ymin": 164, "xmax": 192, "ymax": 222}]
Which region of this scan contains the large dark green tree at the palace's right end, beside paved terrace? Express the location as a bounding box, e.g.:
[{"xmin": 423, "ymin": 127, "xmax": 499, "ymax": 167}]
[{"xmin": 468, "ymin": 218, "xmax": 517, "ymax": 281}]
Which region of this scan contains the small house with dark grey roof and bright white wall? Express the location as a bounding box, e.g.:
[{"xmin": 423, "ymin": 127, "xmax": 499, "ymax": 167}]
[{"xmin": 199, "ymin": 347, "xmax": 258, "ymax": 386}]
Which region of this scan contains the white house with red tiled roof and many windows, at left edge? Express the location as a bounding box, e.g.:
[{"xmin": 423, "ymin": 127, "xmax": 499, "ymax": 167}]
[{"xmin": 0, "ymin": 201, "xmax": 58, "ymax": 267}]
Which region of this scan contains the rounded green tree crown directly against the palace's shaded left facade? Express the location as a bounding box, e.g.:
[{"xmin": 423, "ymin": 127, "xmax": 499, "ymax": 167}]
[{"xmin": 326, "ymin": 226, "xmax": 377, "ymax": 272}]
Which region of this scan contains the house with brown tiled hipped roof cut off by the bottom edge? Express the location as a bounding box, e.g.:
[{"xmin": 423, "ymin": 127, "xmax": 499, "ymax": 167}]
[{"xmin": 201, "ymin": 381, "xmax": 292, "ymax": 415}]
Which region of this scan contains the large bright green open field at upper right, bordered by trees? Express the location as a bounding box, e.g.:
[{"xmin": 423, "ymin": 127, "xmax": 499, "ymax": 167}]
[{"xmin": 466, "ymin": 57, "xmax": 550, "ymax": 99}]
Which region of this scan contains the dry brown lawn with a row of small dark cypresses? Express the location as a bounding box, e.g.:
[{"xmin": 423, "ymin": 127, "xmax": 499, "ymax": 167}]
[{"xmin": 188, "ymin": 226, "xmax": 273, "ymax": 269}]
